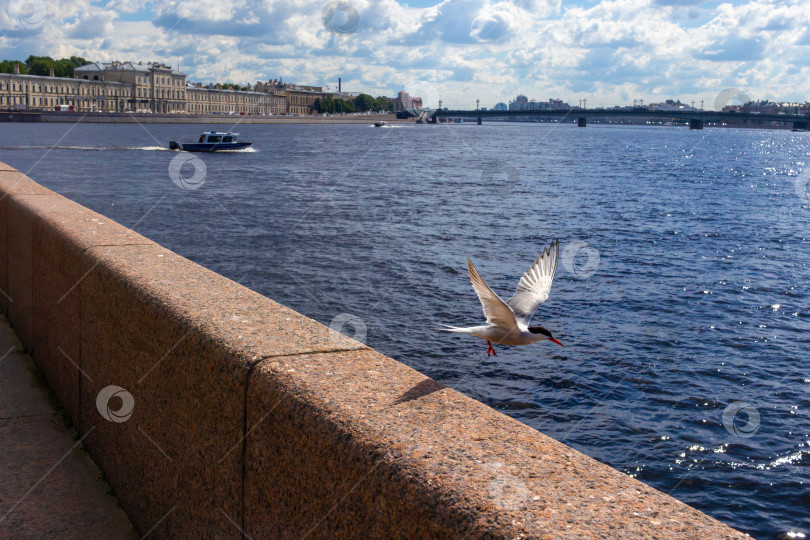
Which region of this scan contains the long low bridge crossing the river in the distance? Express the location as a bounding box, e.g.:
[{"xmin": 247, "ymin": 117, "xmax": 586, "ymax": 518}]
[{"xmin": 430, "ymin": 107, "xmax": 810, "ymax": 131}]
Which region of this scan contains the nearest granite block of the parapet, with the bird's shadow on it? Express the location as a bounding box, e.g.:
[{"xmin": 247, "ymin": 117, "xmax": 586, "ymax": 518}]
[{"xmin": 245, "ymin": 351, "xmax": 744, "ymax": 538}]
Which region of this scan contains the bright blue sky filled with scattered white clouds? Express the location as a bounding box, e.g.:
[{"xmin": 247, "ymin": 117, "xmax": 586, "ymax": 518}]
[{"xmin": 0, "ymin": 0, "xmax": 810, "ymax": 109}]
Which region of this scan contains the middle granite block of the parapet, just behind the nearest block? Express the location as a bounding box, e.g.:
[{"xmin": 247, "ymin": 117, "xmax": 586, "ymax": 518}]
[{"xmin": 79, "ymin": 245, "xmax": 365, "ymax": 538}]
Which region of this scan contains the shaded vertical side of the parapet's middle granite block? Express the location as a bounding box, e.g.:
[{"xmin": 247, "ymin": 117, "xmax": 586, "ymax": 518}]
[{"xmin": 80, "ymin": 246, "xmax": 251, "ymax": 539}]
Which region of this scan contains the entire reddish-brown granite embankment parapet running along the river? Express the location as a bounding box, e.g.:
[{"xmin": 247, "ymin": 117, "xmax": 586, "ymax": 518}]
[{"xmin": 0, "ymin": 163, "xmax": 741, "ymax": 539}]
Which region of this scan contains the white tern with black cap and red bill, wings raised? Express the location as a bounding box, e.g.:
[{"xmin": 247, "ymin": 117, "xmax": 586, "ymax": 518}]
[{"xmin": 441, "ymin": 239, "xmax": 562, "ymax": 356}]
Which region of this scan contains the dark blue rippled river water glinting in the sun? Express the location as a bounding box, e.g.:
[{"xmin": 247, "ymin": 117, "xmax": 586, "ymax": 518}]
[{"xmin": 0, "ymin": 124, "xmax": 810, "ymax": 538}]
